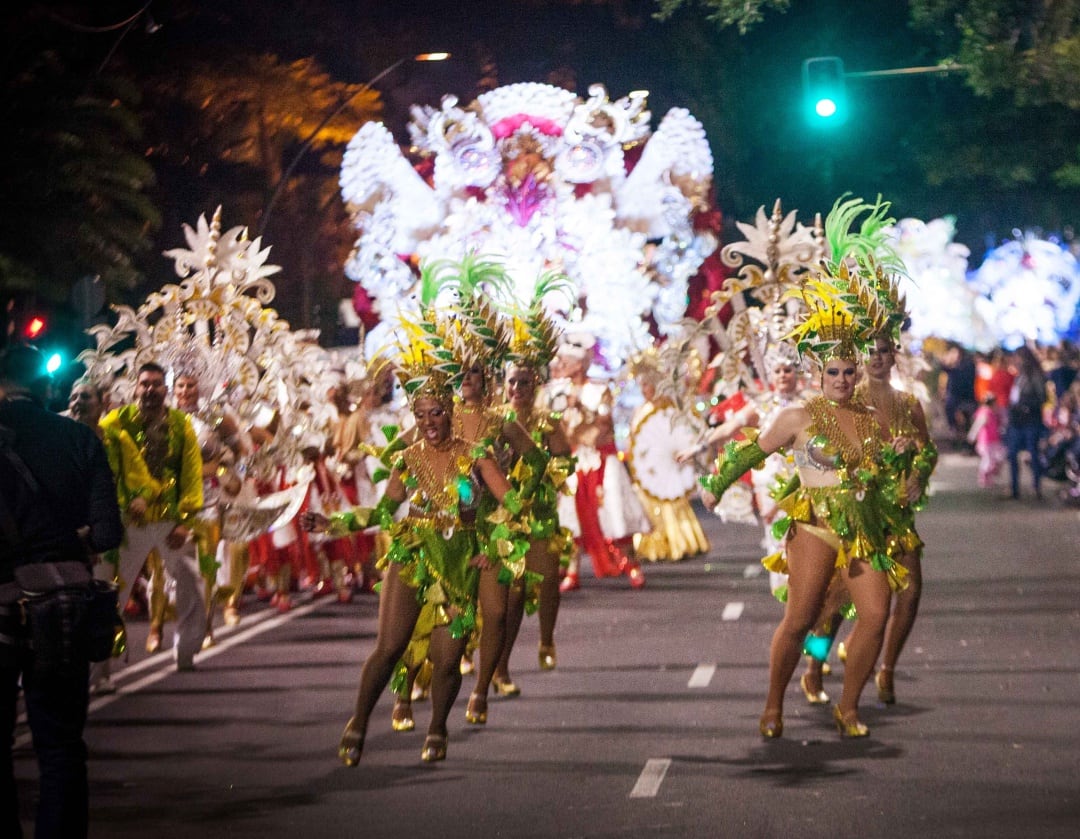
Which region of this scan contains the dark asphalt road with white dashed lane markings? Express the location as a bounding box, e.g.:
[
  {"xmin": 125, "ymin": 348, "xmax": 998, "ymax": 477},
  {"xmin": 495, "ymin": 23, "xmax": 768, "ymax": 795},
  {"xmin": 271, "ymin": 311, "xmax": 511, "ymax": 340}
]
[{"xmin": 10, "ymin": 455, "xmax": 1080, "ymax": 839}]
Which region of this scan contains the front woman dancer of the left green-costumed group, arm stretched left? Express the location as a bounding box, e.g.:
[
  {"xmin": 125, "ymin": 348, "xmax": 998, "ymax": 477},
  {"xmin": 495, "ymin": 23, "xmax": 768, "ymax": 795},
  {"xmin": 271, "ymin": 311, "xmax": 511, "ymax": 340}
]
[{"xmin": 301, "ymin": 315, "xmax": 524, "ymax": 766}]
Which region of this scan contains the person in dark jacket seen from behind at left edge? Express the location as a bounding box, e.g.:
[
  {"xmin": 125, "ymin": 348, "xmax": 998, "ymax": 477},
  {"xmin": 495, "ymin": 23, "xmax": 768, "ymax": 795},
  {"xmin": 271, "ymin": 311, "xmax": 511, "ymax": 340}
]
[{"xmin": 0, "ymin": 346, "xmax": 123, "ymax": 839}]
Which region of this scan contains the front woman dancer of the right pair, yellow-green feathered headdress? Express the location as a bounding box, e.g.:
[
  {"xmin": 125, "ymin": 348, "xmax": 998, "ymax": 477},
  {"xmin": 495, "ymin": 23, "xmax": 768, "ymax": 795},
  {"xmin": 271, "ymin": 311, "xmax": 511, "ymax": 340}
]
[{"xmin": 701, "ymin": 260, "xmax": 905, "ymax": 739}]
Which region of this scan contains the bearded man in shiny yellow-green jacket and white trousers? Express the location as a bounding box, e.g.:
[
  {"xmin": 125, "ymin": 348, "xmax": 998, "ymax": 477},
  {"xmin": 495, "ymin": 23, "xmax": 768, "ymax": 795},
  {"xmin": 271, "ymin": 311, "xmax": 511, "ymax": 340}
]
[{"xmin": 102, "ymin": 362, "xmax": 206, "ymax": 671}]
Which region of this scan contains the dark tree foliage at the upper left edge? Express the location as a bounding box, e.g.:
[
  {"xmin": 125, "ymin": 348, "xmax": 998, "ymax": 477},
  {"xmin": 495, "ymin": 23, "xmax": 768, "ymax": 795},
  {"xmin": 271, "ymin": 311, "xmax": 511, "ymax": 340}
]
[{"xmin": 0, "ymin": 50, "xmax": 160, "ymax": 301}]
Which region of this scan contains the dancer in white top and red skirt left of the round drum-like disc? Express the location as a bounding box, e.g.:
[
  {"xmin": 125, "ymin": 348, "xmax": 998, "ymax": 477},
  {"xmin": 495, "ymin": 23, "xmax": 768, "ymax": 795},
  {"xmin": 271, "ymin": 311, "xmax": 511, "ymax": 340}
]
[{"xmin": 548, "ymin": 333, "xmax": 650, "ymax": 592}]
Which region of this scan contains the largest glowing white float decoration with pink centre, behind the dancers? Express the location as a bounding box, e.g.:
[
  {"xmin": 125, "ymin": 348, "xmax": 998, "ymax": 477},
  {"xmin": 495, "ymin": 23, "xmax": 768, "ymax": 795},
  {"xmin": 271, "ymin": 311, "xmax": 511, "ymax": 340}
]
[{"xmin": 340, "ymin": 83, "xmax": 717, "ymax": 369}]
